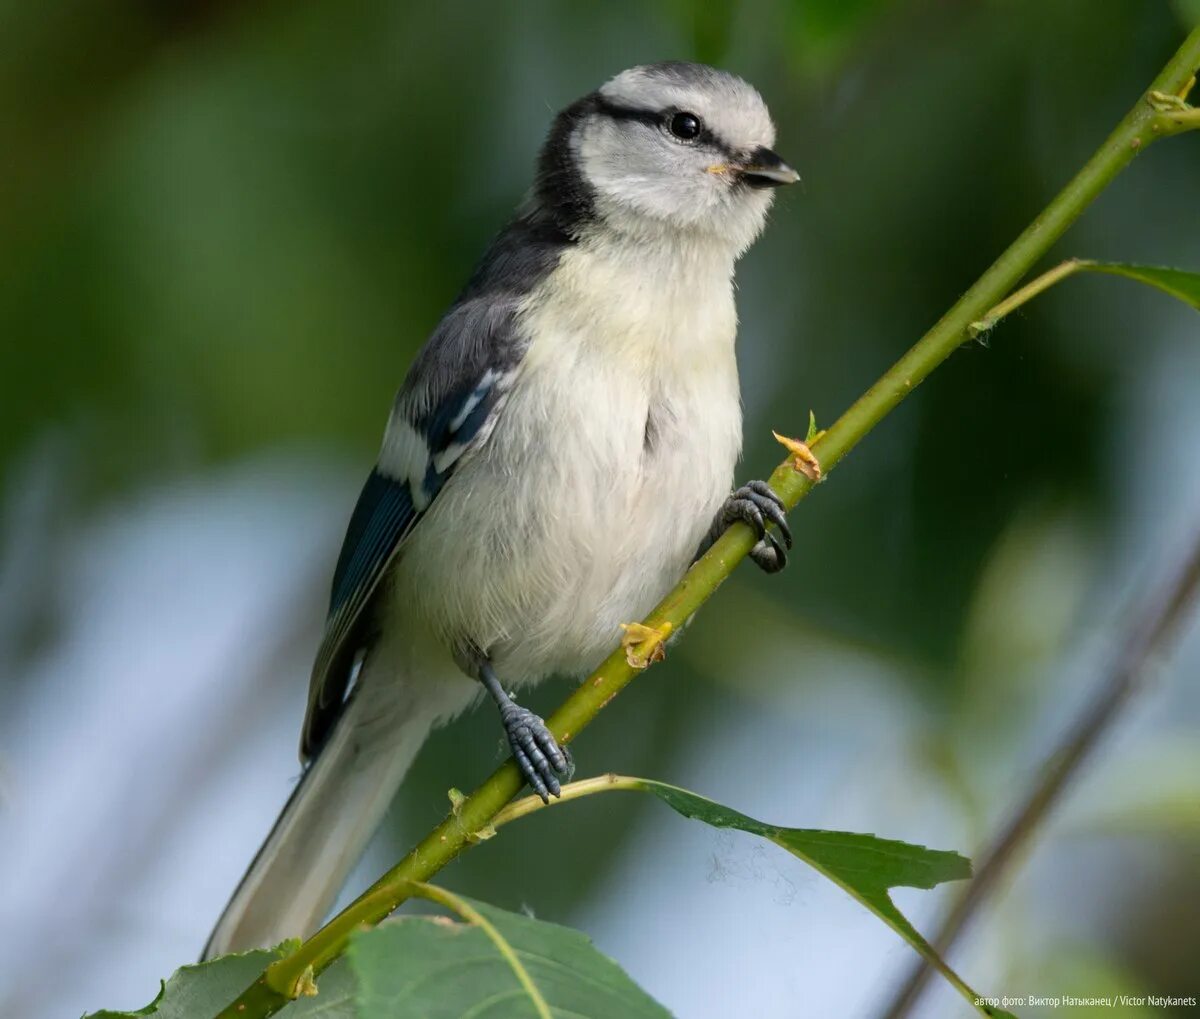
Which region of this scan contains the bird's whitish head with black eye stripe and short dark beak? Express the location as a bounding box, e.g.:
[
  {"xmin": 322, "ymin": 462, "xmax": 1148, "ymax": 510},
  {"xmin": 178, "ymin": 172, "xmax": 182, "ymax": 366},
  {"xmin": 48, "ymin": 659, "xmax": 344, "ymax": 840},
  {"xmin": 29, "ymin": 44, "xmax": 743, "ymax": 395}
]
[{"xmin": 536, "ymin": 62, "xmax": 799, "ymax": 254}]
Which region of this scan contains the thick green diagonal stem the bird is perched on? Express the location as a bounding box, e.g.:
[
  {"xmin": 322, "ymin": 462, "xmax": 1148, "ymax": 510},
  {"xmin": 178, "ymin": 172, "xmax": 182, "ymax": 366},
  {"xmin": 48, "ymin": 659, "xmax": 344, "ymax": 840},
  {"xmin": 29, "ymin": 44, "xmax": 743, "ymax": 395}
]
[{"xmin": 221, "ymin": 28, "xmax": 1200, "ymax": 1019}]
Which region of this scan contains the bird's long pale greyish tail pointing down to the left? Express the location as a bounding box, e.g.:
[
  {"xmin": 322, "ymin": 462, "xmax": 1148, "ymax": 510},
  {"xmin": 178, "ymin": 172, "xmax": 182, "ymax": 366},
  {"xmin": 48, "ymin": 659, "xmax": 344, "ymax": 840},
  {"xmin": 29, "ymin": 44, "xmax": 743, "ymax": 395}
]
[{"xmin": 203, "ymin": 677, "xmax": 436, "ymax": 959}]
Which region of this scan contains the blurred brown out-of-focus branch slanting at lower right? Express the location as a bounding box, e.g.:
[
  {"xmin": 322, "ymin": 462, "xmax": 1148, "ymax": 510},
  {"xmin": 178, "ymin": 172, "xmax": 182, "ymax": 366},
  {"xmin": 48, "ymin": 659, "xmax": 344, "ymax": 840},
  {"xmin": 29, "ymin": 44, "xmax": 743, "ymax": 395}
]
[{"xmin": 883, "ymin": 534, "xmax": 1200, "ymax": 1019}]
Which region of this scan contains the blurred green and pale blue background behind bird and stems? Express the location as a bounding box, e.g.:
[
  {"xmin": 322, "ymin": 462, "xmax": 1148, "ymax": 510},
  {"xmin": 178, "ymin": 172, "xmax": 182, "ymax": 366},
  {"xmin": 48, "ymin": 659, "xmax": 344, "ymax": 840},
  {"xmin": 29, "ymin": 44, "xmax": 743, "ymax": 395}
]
[{"xmin": 0, "ymin": 0, "xmax": 1200, "ymax": 1019}]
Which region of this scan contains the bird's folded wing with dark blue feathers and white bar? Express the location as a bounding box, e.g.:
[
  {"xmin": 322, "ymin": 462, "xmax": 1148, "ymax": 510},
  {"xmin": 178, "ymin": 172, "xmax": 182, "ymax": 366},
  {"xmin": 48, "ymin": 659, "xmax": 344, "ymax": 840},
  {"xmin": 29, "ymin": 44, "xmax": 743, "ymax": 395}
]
[{"xmin": 300, "ymin": 294, "xmax": 523, "ymax": 760}]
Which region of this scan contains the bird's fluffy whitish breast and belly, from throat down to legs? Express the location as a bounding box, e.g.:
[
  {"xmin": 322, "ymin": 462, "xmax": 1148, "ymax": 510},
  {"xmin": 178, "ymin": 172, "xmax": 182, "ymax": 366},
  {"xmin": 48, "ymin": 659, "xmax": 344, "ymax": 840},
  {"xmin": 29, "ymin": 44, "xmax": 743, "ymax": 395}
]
[{"xmin": 395, "ymin": 232, "xmax": 742, "ymax": 684}]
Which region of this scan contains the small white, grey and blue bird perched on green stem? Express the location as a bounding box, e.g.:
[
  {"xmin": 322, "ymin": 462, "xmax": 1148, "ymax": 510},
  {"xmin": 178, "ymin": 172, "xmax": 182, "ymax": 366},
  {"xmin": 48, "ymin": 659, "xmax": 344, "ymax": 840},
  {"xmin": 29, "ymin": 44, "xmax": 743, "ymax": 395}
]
[{"xmin": 204, "ymin": 61, "xmax": 799, "ymax": 958}]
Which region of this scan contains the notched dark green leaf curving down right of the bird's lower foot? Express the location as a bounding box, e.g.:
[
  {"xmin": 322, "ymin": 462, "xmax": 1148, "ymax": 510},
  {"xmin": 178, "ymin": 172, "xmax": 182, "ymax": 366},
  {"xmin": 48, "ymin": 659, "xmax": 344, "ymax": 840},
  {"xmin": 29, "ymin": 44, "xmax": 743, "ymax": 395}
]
[{"xmin": 637, "ymin": 779, "xmax": 1013, "ymax": 1019}]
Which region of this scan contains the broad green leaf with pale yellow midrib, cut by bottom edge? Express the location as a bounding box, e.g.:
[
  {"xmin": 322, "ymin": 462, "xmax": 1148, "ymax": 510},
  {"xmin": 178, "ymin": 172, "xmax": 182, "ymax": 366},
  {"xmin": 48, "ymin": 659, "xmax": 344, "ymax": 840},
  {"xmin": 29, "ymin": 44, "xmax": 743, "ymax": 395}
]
[{"xmin": 348, "ymin": 898, "xmax": 670, "ymax": 1019}]
